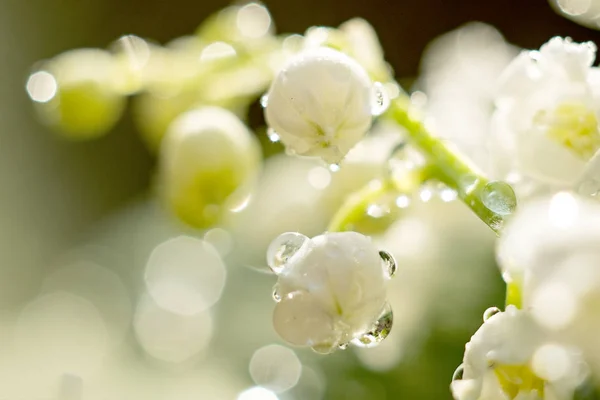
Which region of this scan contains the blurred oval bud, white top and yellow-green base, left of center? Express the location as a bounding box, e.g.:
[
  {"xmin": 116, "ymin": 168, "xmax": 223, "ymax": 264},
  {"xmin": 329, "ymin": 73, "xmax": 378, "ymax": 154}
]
[{"xmin": 160, "ymin": 107, "xmax": 261, "ymax": 228}]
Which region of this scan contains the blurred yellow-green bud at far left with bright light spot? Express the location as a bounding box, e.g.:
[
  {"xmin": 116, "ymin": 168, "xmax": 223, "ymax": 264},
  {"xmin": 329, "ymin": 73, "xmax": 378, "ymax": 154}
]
[{"xmin": 26, "ymin": 49, "xmax": 126, "ymax": 139}]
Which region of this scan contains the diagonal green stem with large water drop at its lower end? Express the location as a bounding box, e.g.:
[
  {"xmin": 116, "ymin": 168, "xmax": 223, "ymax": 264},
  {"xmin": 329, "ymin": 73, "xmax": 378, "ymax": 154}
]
[{"xmin": 388, "ymin": 95, "xmax": 516, "ymax": 234}]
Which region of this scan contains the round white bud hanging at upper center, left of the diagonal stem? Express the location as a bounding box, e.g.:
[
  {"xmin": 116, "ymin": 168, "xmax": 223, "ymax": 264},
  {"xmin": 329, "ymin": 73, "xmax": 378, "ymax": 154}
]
[{"xmin": 265, "ymin": 48, "xmax": 375, "ymax": 163}]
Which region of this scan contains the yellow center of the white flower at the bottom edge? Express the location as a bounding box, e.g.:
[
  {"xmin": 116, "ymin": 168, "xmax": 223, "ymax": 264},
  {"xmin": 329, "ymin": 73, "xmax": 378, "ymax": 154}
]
[{"xmin": 494, "ymin": 365, "xmax": 544, "ymax": 400}]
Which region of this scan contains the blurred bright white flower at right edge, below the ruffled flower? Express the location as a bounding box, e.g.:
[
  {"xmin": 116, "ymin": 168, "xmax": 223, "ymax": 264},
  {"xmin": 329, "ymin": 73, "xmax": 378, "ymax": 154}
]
[{"xmin": 497, "ymin": 192, "xmax": 600, "ymax": 373}]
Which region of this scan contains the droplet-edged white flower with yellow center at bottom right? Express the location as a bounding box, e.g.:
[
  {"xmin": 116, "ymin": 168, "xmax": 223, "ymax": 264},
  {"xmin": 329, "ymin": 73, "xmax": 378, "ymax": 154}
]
[{"xmin": 451, "ymin": 306, "xmax": 585, "ymax": 400}]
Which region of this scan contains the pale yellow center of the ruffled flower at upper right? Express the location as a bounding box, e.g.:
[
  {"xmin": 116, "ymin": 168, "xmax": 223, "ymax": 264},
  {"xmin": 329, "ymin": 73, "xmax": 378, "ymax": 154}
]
[{"xmin": 534, "ymin": 102, "xmax": 600, "ymax": 161}]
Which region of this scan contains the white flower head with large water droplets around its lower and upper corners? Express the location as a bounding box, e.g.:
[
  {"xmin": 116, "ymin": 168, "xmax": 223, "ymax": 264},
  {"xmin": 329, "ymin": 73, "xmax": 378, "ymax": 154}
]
[{"xmin": 267, "ymin": 232, "xmax": 395, "ymax": 353}]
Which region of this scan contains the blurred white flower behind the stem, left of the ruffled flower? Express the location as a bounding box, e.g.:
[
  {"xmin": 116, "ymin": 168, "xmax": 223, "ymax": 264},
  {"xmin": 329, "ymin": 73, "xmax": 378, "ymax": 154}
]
[{"xmin": 420, "ymin": 22, "xmax": 518, "ymax": 170}]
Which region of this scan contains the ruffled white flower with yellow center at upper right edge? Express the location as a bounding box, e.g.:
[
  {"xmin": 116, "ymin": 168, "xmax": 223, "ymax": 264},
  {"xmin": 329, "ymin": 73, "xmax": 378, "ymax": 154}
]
[{"xmin": 491, "ymin": 37, "xmax": 600, "ymax": 197}]
